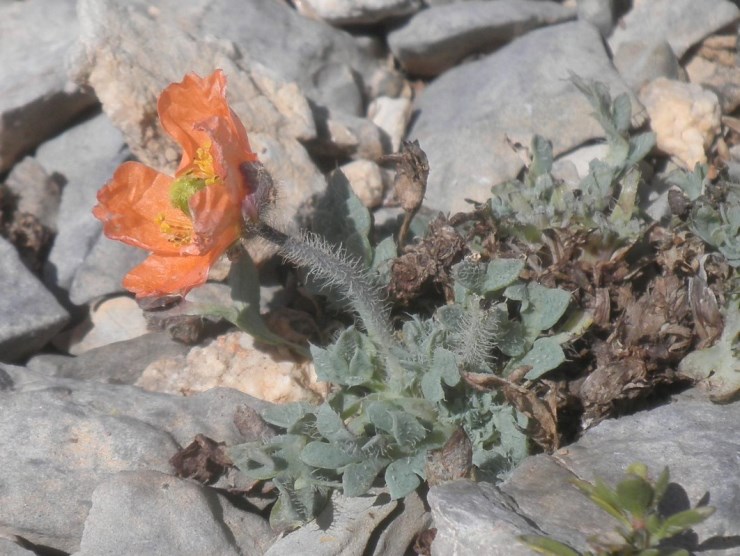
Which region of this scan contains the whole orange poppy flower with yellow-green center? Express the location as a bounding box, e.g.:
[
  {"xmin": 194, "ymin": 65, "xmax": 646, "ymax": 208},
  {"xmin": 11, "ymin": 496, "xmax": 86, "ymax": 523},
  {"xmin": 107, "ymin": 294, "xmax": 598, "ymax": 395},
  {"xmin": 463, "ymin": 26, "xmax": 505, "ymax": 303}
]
[{"xmin": 93, "ymin": 70, "xmax": 259, "ymax": 298}]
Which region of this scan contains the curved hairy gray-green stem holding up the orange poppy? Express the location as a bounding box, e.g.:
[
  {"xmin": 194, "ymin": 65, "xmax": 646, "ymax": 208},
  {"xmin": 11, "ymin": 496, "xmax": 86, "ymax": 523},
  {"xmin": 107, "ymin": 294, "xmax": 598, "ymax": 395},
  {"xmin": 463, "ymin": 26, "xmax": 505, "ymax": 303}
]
[{"xmin": 249, "ymin": 222, "xmax": 401, "ymax": 386}]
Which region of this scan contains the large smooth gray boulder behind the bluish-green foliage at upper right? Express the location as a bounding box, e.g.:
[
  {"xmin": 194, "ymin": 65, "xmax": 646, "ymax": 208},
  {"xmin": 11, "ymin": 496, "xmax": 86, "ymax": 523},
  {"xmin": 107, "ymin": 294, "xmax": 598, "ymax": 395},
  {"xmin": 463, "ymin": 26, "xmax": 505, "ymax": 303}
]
[{"xmin": 409, "ymin": 21, "xmax": 641, "ymax": 212}]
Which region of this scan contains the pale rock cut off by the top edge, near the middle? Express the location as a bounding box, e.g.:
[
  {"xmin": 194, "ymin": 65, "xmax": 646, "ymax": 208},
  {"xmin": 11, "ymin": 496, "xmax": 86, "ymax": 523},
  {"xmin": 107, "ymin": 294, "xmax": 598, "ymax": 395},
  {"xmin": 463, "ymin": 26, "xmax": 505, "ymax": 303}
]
[{"xmin": 297, "ymin": 0, "xmax": 421, "ymax": 25}]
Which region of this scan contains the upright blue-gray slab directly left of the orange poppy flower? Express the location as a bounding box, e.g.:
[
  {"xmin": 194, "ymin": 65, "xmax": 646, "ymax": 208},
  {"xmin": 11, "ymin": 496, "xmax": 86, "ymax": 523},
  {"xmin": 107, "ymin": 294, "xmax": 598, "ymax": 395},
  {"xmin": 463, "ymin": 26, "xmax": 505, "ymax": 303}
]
[{"xmin": 36, "ymin": 114, "xmax": 129, "ymax": 296}]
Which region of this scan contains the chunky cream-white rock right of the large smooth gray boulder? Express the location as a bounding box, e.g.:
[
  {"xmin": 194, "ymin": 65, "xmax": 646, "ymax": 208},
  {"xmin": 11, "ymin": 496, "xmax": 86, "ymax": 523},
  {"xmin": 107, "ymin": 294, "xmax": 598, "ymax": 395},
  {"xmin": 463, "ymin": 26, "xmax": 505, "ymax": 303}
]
[{"xmin": 640, "ymin": 77, "xmax": 721, "ymax": 170}]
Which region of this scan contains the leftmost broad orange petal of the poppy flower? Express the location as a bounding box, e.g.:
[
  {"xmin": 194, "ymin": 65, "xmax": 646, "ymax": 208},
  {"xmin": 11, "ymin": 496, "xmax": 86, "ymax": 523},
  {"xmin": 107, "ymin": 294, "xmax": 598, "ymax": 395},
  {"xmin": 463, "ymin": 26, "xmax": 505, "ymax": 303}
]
[{"xmin": 93, "ymin": 162, "xmax": 192, "ymax": 255}]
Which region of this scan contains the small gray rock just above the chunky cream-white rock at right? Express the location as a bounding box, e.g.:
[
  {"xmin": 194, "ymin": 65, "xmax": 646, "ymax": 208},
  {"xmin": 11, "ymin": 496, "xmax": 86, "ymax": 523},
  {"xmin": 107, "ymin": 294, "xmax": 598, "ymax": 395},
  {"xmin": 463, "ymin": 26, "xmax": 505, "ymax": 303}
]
[{"xmin": 614, "ymin": 39, "xmax": 681, "ymax": 93}]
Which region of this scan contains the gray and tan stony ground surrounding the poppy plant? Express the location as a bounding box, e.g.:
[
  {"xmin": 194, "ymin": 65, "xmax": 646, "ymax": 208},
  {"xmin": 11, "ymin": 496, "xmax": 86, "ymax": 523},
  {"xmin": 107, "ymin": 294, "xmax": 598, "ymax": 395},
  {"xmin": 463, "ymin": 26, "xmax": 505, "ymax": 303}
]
[{"xmin": 0, "ymin": 0, "xmax": 740, "ymax": 556}]
